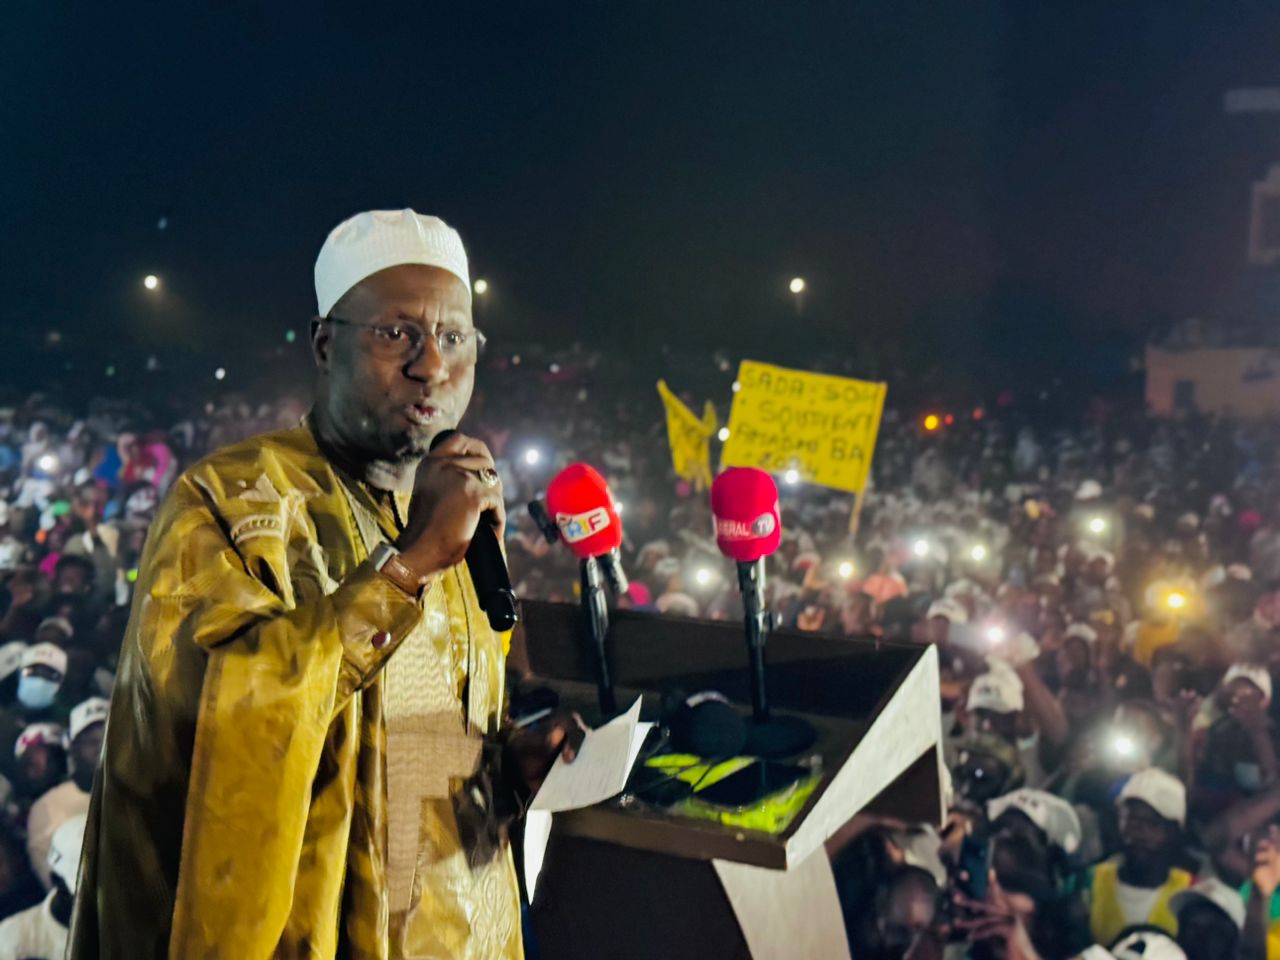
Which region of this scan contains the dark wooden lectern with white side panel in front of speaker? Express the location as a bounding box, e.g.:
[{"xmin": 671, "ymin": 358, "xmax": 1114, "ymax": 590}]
[{"xmin": 512, "ymin": 602, "xmax": 943, "ymax": 960}]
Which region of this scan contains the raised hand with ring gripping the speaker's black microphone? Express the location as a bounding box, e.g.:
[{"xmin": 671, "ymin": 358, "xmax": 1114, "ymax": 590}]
[{"xmin": 396, "ymin": 434, "xmax": 507, "ymax": 577}]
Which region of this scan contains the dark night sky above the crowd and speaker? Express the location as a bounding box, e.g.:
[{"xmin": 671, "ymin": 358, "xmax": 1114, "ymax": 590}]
[{"xmin": 0, "ymin": 0, "xmax": 1280, "ymax": 394}]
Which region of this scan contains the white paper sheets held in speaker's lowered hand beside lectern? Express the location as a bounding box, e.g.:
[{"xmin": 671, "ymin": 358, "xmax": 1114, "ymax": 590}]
[{"xmin": 525, "ymin": 696, "xmax": 653, "ymax": 900}]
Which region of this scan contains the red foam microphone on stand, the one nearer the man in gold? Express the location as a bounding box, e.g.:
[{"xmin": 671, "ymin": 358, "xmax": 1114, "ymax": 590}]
[{"xmin": 540, "ymin": 463, "xmax": 627, "ymax": 717}]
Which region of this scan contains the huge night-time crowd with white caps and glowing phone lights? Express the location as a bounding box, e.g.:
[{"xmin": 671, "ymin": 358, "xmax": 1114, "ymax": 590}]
[{"xmin": 0, "ymin": 352, "xmax": 1280, "ymax": 960}]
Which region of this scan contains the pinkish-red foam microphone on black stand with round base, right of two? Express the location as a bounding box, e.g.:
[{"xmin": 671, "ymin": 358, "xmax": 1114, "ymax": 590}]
[{"xmin": 712, "ymin": 467, "xmax": 817, "ymax": 756}]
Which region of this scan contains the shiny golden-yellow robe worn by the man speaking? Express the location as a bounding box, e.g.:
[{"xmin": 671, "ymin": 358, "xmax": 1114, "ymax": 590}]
[{"xmin": 69, "ymin": 428, "xmax": 522, "ymax": 960}]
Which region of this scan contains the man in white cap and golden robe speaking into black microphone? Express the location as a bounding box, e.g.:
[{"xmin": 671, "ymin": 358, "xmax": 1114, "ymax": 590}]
[{"xmin": 70, "ymin": 210, "xmax": 564, "ymax": 960}]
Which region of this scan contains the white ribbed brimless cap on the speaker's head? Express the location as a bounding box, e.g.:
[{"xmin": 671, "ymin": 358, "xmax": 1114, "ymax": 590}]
[{"xmin": 316, "ymin": 209, "xmax": 471, "ymax": 316}]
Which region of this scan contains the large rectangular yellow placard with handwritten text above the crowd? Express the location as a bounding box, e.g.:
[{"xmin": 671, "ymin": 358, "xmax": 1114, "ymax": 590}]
[{"xmin": 722, "ymin": 360, "xmax": 887, "ymax": 493}]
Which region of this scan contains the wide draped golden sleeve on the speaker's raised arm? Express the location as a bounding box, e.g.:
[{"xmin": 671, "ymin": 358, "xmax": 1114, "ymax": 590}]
[{"xmin": 146, "ymin": 477, "xmax": 422, "ymax": 959}]
